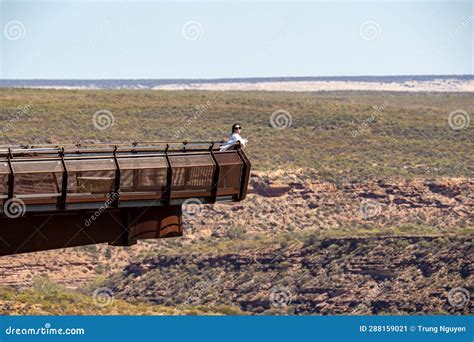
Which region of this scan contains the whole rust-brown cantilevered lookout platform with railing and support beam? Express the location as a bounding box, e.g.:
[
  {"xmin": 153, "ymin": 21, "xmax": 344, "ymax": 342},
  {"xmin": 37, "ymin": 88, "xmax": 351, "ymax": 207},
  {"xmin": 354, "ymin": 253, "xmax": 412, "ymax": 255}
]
[{"xmin": 0, "ymin": 142, "xmax": 251, "ymax": 255}]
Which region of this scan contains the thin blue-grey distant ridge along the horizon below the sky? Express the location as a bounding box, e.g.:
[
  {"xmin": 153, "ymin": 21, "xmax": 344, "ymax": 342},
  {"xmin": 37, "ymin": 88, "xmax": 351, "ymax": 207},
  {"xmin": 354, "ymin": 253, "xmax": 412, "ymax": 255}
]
[{"xmin": 0, "ymin": 75, "xmax": 474, "ymax": 89}]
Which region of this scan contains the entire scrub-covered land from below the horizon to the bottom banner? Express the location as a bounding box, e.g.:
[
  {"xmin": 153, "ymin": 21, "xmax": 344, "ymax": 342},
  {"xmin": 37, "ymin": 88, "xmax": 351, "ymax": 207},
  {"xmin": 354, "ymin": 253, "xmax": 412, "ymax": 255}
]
[{"xmin": 0, "ymin": 89, "xmax": 474, "ymax": 314}]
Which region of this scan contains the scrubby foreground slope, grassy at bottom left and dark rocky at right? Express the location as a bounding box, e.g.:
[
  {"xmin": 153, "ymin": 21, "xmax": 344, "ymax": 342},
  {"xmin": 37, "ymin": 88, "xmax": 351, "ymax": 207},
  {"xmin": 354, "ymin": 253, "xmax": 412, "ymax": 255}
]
[{"xmin": 0, "ymin": 231, "xmax": 472, "ymax": 315}]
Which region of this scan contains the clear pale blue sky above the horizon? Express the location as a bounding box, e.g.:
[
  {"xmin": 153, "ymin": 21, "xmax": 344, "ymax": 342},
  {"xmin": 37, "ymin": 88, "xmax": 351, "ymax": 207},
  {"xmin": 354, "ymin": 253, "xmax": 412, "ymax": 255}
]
[{"xmin": 0, "ymin": 0, "xmax": 474, "ymax": 79}]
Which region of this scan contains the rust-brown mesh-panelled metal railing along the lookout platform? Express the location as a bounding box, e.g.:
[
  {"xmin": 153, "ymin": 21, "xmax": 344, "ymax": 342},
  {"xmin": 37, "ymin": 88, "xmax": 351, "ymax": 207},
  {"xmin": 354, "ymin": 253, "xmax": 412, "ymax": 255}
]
[{"xmin": 0, "ymin": 141, "xmax": 250, "ymax": 210}]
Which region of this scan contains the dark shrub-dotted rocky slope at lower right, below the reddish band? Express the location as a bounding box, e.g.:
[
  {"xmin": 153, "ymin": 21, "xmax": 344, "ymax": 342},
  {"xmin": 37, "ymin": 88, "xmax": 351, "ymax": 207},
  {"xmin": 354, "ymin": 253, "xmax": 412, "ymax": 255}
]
[{"xmin": 108, "ymin": 237, "xmax": 474, "ymax": 314}]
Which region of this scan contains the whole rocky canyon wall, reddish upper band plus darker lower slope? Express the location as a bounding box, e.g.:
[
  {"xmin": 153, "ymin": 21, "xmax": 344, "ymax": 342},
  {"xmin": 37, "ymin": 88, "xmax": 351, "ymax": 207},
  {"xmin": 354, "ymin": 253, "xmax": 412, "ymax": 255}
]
[{"xmin": 0, "ymin": 170, "xmax": 474, "ymax": 314}]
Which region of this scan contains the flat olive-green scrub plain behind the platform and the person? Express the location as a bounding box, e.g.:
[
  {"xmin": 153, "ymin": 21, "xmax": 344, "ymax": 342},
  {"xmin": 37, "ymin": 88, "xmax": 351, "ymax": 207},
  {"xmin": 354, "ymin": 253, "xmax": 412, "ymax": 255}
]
[{"xmin": 0, "ymin": 89, "xmax": 474, "ymax": 179}]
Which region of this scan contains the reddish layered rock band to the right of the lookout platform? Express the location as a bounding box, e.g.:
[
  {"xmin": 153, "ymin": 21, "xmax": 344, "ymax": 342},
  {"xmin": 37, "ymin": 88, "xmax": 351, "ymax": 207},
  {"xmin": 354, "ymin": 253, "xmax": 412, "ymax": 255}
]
[{"xmin": 185, "ymin": 171, "xmax": 474, "ymax": 236}]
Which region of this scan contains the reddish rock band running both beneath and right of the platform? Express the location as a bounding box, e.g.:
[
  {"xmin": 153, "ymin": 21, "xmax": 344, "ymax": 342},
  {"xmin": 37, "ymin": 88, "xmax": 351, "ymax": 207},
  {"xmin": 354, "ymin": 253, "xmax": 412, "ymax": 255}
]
[{"xmin": 0, "ymin": 170, "xmax": 474, "ymax": 294}]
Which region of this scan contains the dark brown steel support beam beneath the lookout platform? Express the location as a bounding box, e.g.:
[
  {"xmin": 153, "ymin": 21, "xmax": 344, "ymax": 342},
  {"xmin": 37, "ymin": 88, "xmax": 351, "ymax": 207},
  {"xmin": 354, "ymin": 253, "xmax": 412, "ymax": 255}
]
[{"xmin": 0, "ymin": 205, "xmax": 182, "ymax": 255}]
